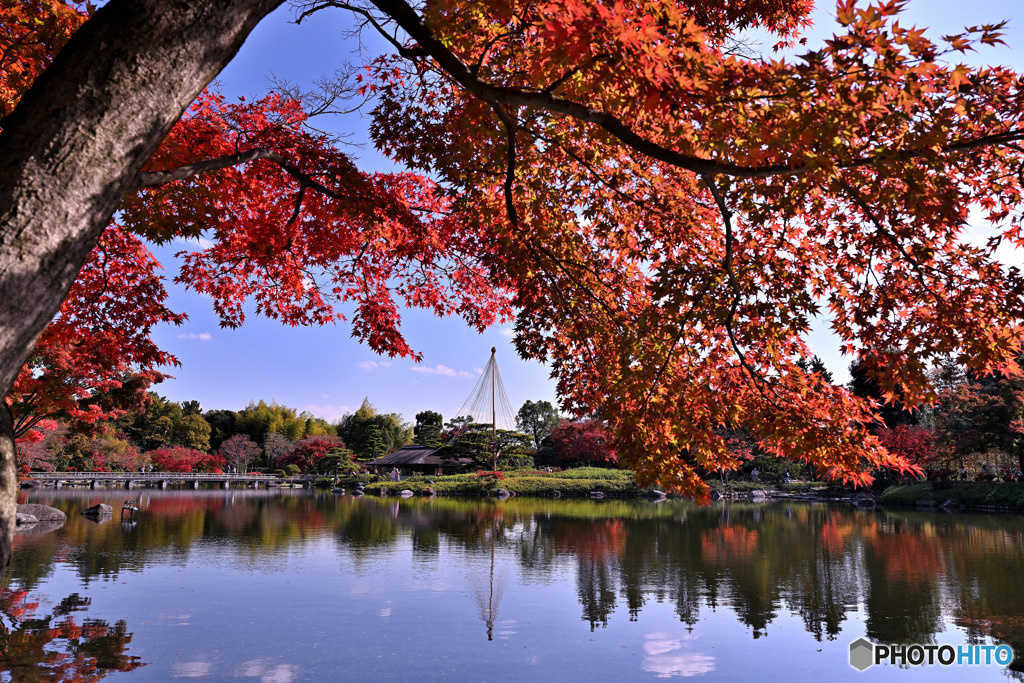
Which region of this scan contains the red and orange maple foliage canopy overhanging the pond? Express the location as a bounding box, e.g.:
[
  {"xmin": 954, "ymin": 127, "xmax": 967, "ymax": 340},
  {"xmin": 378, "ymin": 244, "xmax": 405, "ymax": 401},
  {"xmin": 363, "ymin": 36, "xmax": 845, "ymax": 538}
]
[{"xmin": 4, "ymin": 0, "xmax": 1024, "ymax": 498}]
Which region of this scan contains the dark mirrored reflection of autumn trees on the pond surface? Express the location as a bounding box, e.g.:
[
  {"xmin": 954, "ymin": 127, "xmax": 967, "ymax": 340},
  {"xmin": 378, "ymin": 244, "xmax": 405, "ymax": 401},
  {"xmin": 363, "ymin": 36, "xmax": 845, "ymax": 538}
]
[{"xmin": 8, "ymin": 492, "xmax": 1024, "ymax": 681}]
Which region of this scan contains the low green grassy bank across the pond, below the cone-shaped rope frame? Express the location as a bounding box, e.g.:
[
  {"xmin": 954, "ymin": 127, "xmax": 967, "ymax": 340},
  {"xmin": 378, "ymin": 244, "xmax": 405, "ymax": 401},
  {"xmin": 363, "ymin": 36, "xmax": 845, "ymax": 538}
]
[{"xmin": 331, "ymin": 467, "xmax": 642, "ymax": 497}]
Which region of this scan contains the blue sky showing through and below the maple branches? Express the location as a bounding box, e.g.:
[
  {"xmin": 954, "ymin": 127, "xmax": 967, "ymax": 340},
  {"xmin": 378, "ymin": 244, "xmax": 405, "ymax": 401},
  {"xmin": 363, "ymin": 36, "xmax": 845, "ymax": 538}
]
[{"xmin": 144, "ymin": 0, "xmax": 1024, "ymax": 428}]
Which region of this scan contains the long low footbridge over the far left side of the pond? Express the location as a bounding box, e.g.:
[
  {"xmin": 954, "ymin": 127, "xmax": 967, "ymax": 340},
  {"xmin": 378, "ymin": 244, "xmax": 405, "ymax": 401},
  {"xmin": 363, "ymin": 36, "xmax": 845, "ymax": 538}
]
[{"xmin": 28, "ymin": 472, "xmax": 313, "ymax": 488}]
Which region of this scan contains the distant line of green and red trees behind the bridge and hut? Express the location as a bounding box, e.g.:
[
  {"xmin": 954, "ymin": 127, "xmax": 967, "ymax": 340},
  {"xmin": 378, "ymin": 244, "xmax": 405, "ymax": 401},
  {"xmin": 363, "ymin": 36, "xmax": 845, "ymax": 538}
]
[{"xmin": 17, "ymin": 391, "xmax": 616, "ymax": 472}]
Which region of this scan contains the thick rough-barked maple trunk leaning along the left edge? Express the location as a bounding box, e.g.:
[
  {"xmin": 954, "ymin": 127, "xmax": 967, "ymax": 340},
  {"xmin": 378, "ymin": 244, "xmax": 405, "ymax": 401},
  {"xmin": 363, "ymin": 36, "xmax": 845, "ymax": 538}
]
[{"xmin": 0, "ymin": 0, "xmax": 282, "ymax": 566}]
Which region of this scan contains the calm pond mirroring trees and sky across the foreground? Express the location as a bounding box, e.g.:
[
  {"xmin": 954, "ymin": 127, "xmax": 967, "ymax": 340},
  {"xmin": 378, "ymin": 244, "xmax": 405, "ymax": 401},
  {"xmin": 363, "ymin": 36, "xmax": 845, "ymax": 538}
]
[{"xmin": 0, "ymin": 489, "xmax": 1024, "ymax": 683}]
